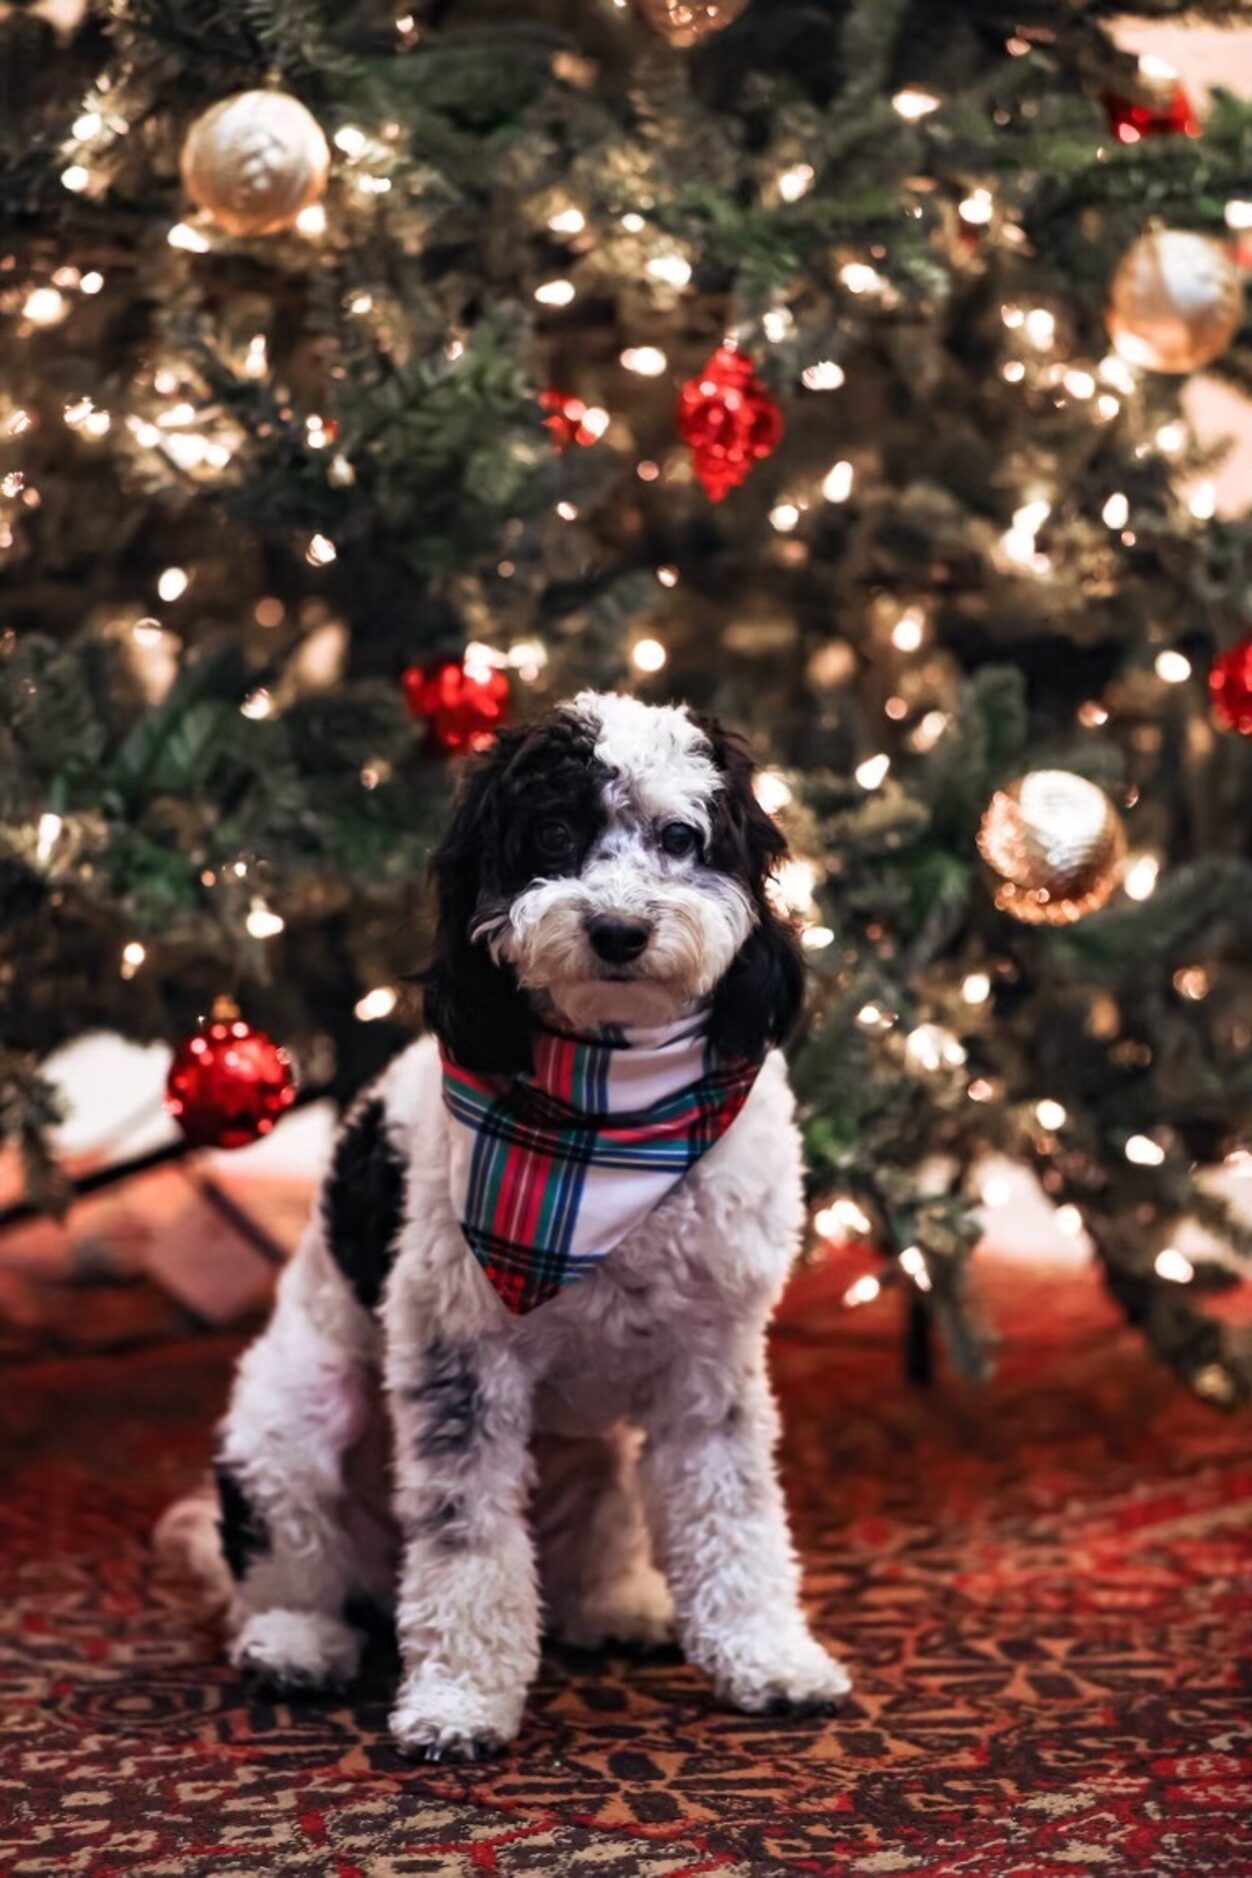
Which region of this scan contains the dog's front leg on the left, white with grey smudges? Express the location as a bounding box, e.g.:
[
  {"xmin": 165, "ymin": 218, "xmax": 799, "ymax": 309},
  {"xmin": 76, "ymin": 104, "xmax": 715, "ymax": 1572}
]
[{"xmin": 387, "ymin": 1332, "xmax": 539, "ymax": 1760}]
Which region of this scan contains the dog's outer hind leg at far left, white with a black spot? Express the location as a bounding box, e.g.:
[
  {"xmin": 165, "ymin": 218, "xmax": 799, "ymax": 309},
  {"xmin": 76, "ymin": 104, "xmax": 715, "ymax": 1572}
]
[{"xmin": 218, "ymin": 1226, "xmax": 377, "ymax": 1692}]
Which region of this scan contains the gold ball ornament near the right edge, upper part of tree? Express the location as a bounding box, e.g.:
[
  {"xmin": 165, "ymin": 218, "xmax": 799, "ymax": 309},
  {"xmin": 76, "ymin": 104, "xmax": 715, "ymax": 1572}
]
[{"xmin": 1107, "ymin": 229, "xmax": 1243, "ymax": 372}]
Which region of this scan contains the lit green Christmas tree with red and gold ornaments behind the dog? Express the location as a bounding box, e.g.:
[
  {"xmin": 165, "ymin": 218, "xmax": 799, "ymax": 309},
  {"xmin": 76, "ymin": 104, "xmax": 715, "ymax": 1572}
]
[{"xmin": 0, "ymin": 0, "xmax": 1252, "ymax": 1405}]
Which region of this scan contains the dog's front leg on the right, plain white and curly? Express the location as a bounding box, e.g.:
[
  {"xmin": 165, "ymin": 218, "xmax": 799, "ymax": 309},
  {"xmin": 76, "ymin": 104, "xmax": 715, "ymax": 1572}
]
[{"xmin": 644, "ymin": 1347, "xmax": 852, "ymax": 1713}]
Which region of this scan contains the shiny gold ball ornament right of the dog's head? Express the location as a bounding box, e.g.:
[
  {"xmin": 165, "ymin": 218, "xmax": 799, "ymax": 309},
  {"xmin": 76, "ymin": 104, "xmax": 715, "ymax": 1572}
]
[{"xmin": 978, "ymin": 770, "xmax": 1126, "ymax": 926}]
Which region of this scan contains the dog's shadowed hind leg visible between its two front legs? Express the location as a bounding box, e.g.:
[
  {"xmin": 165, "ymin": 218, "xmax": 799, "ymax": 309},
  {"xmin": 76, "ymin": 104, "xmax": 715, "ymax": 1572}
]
[{"xmin": 533, "ymin": 1424, "xmax": 674, "ymax": 1649}]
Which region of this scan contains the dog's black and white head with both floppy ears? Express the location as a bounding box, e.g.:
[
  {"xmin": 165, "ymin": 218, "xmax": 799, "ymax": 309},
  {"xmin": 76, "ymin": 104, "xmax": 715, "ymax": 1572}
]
[{"xmin": 426, "ymin": 691, "xmax": 803, "ymax": 1070}]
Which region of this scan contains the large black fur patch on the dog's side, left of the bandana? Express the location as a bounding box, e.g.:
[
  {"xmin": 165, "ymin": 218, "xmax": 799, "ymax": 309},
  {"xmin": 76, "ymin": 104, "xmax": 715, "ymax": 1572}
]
[{"xmin": 323, "ymin": 1097, "xmax": 404, "ymax": 1311}]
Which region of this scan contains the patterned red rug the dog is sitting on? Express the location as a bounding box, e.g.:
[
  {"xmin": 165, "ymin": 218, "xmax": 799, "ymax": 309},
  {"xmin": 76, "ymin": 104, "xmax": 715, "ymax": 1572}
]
[{"xmin": 0, "ymin": 1268, "xmax": 1252, "ymax": 1878}]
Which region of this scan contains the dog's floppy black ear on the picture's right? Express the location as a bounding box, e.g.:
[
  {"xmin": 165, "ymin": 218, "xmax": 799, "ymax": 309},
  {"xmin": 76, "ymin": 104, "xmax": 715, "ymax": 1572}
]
[{"xmin": 696, "ymin": 719, "xmax": 805, "ymax": 1061}]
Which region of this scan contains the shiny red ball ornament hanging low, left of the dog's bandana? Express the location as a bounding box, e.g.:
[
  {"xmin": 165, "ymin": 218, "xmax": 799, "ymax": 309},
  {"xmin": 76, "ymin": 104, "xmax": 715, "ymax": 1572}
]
[{"xmin": 165, "ymin": 1018, "xmax": 295, "ymax": 1147}]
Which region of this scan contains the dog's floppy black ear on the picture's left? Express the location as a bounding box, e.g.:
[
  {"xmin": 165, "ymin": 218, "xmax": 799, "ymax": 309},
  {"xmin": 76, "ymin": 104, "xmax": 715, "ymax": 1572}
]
[{"xmin": 422, "ymin": 731, "xmax": 531, "ymax": 1074}]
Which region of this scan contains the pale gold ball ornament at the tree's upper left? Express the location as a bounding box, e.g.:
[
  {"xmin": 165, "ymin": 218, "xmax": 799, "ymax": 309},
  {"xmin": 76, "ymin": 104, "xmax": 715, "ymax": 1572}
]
[{"xmin": 182, "ymin": 92, "xmax": 330, "ymax": 235}]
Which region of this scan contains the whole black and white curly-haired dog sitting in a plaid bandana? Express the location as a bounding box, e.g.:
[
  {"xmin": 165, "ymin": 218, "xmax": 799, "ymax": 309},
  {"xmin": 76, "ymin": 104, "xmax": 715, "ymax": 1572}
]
[{"xmin": 203, "ymin": 693, "xmax": 848, "ymax": 1758}]
